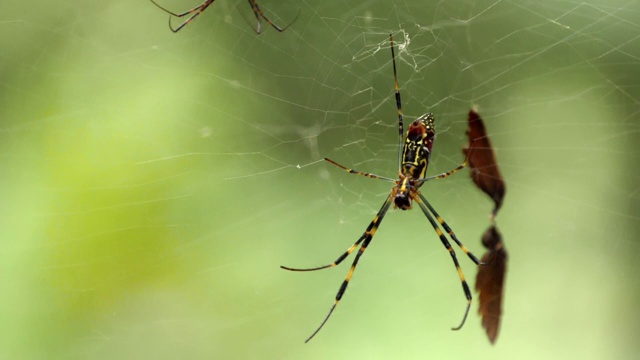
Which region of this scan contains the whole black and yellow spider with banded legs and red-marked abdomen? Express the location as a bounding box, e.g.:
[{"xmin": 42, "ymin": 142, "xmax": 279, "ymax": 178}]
[{"xmin": 280, "ymin": 34, "xmax": 483, "ymax": 342}]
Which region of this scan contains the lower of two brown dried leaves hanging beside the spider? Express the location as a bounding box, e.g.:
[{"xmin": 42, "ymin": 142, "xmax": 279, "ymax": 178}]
[{"xmin": 476, "ymin": 226, "xmax": 507, "ymax": 344}]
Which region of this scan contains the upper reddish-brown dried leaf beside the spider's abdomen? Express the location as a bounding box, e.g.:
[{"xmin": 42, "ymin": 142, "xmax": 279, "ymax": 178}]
[{"xmin": 463, "ymin": 109, "xmax": 505, "ymax": 219}]
